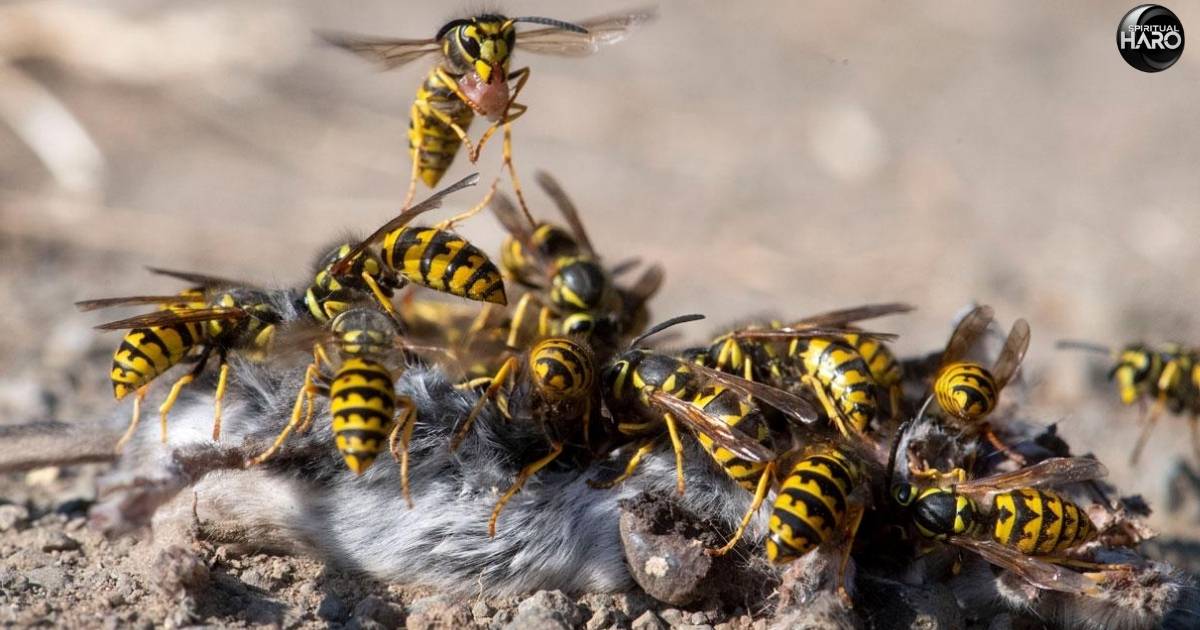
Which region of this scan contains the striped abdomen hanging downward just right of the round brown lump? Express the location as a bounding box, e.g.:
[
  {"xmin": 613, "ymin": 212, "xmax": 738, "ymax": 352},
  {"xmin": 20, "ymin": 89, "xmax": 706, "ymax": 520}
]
[{"xmin": 767, "ymin": 449, "xmax": 863, "ymax": 564}]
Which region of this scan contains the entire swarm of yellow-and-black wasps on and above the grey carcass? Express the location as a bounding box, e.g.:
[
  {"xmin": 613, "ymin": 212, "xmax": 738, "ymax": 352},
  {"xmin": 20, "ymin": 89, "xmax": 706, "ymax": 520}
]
[{"xmin": 78, "ymin": 6, "xmax": 1152, "ymax": 604}]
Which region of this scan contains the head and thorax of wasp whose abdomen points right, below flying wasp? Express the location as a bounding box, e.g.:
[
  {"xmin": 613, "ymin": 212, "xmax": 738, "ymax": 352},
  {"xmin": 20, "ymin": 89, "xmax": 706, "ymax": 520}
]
[{"xmin": 301, "ymin": 244, "xmax": 400, "ymax": 323}]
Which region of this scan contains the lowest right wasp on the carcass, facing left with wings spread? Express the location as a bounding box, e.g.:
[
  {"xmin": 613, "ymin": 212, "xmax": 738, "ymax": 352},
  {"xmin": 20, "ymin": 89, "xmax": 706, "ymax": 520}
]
[{"xmin": 889, "ymin": 441, "xmax": 1115, "ymax": 594}]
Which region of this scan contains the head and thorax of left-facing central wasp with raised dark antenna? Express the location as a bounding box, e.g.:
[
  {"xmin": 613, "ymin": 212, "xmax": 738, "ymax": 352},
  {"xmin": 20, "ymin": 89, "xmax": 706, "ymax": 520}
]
[{"xmin": 601, "ymin": 349, "xmax": 698, "ymax": 438}]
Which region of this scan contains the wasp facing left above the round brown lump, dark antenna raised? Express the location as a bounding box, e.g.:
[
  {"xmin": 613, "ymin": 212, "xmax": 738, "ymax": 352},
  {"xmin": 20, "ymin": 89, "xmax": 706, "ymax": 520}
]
[{"xmin": 590, "ymin": 316, "xmax": 826, "ymax": 554}]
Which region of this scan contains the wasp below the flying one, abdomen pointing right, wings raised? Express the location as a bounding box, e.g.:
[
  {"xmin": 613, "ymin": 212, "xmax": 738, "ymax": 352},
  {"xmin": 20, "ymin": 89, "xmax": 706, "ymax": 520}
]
[{"xmin": 314, "ymin": 174, "xmax": 508, "ymax": 322}]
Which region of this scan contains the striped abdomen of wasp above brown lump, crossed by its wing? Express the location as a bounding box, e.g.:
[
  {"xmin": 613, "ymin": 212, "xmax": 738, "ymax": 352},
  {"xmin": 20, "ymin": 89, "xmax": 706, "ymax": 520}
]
[{"xmin": 691, "ymin": 385, "xmax": 773, "ymax": 492}]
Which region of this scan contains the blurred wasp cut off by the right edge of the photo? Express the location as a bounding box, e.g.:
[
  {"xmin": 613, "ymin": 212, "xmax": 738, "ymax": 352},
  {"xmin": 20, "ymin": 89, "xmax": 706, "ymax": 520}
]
[{"xmin": 1058, "ymin": 341, "xmax": 1200, "ymax": 464}]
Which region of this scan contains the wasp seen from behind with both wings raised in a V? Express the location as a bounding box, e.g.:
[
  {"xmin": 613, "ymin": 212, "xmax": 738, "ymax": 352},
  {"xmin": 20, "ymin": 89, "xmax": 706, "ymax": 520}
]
[{"xmin": 926, "ymin": 306, "xmax": 1030, "ymax": 463}]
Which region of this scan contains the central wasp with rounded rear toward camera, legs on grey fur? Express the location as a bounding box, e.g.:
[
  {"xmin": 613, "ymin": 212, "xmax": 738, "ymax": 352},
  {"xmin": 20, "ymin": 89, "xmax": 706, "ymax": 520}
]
[{"xmin": 450, "ymin": 336, "xmax": 599, "ymax": 536}]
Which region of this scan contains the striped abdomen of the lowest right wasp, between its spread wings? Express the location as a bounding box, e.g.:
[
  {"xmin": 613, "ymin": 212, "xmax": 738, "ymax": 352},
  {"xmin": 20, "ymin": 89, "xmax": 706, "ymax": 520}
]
[{"xmin": 991, "ymin": 488, "xmax": 1096, "ymax": 556}]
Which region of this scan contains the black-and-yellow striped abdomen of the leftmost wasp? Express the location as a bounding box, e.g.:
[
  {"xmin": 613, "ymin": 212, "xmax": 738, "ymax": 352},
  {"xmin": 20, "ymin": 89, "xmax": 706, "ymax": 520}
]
[{"xmin": 109, "ymin": 323, "xmax": 204, "ymax": 400}]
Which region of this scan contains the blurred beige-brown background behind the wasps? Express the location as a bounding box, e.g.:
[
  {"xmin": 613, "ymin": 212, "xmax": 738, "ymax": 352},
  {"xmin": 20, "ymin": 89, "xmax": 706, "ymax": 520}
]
[{"xmin": 0, "ymin": 0, "xmax": 1200, "ymax": 533}]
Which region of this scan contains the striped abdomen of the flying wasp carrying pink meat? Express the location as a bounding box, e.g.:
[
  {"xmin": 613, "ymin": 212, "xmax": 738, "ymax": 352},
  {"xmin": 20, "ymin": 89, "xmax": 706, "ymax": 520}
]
[{"xmin": 408, "ymin": 68, "xmax": 475, "ymax": 188}]
